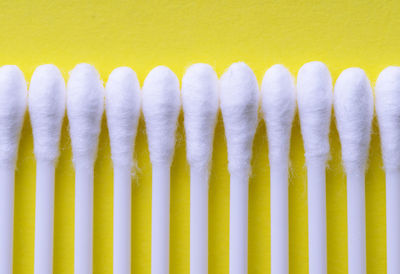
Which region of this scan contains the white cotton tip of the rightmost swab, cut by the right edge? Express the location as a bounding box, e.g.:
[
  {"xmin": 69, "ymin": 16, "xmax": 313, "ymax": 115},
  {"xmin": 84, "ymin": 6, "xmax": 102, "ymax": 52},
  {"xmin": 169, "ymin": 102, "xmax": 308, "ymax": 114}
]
[{"xmin": 375, "ymin": 67, "xmax": 400, "ymax": 170}]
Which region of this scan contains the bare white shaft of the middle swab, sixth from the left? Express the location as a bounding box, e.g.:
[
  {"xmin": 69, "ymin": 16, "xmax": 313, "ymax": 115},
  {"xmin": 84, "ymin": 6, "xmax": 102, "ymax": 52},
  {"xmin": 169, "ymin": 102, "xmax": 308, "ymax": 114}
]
[{"xmin": 190, "ymin": 165, "xmax": 209, "ymax": 274}]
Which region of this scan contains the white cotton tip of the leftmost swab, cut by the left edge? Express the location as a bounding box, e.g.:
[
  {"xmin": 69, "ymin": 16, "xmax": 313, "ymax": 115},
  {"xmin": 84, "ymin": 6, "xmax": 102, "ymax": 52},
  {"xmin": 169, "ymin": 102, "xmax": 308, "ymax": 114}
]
[{"xmin": 0, "ymin": 65, "xmax": 27, "ymax": 165}]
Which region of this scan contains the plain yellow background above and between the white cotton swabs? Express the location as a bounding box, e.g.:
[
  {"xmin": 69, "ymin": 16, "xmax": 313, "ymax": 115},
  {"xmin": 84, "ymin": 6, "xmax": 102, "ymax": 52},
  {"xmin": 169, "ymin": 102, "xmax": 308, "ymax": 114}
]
[{"xmin": 0, "ymin": 0, "xmax": 400, "ymax": 274}]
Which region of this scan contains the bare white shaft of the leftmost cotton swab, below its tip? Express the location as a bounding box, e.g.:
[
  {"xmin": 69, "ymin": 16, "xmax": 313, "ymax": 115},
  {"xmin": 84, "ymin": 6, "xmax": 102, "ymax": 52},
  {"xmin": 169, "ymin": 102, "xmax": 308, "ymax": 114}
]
[{"xmin": 0, "ymin": 164, "xmax": 15, "ymax": 274}]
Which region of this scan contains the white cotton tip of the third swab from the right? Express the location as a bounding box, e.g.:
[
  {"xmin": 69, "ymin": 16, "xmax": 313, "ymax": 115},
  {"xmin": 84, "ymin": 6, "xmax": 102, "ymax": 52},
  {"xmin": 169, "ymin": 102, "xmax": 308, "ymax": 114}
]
[{"xmin": 297, "ymin": 62, "xmax": 333, "ymax": 164}]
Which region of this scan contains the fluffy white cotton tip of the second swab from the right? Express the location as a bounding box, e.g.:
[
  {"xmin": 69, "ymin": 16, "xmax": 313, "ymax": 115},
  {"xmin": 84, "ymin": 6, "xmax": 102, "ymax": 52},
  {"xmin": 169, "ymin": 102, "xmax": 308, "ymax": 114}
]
[{"xmin": 333, "ymin": 68, "xmax": 374, "ymax": 170}]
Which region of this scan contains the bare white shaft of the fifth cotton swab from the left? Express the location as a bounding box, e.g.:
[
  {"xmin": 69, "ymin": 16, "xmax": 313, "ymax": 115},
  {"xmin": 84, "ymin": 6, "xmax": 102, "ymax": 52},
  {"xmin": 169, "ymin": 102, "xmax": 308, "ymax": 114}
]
[{"xmin": 151, "ymin": 164, "xmax": 170, "ymax": 273}]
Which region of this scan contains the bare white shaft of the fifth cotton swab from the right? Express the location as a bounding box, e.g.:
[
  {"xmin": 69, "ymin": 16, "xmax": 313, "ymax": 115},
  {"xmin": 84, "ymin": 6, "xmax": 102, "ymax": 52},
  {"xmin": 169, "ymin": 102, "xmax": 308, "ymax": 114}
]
[{"xmin": 229, "ymin": 173, "xmax": 249, "ymax": 274}]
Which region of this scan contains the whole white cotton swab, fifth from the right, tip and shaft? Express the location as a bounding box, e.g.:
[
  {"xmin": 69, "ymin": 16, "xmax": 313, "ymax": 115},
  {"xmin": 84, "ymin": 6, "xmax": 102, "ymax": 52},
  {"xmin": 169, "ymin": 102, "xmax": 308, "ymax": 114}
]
[{"xmin": 220, "ymin": 63, "xmax": 259, "ymax": 274}]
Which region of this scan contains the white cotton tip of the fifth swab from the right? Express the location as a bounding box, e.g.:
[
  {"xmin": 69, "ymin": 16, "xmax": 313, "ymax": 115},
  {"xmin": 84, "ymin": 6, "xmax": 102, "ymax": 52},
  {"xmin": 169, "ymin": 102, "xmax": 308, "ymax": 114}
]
[{"xmin": 220, "ymin": 62, "xmax": 259, "ymax": 175}]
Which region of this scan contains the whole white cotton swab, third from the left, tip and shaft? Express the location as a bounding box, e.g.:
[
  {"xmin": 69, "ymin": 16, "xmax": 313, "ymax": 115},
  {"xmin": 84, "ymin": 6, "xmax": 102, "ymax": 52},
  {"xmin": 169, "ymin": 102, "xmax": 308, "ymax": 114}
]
[{"xmin": 67, "ymin": 64, "xmax": 104, "ymax": 274}]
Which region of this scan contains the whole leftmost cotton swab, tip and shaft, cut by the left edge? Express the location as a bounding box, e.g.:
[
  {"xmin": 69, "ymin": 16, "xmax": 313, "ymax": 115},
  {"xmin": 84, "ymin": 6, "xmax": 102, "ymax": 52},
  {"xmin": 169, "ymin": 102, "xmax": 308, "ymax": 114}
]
[{"xmin": 0, "ymin": 65, "xmax": 27, "ymax": 274}]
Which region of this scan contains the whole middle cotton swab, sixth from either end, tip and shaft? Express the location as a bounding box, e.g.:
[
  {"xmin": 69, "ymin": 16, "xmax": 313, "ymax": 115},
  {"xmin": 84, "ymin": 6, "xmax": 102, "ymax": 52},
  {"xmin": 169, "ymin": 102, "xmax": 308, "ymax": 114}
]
[{"xmin": 182, "ymin": 64, "xmax": 219, "ymax": 274}]
